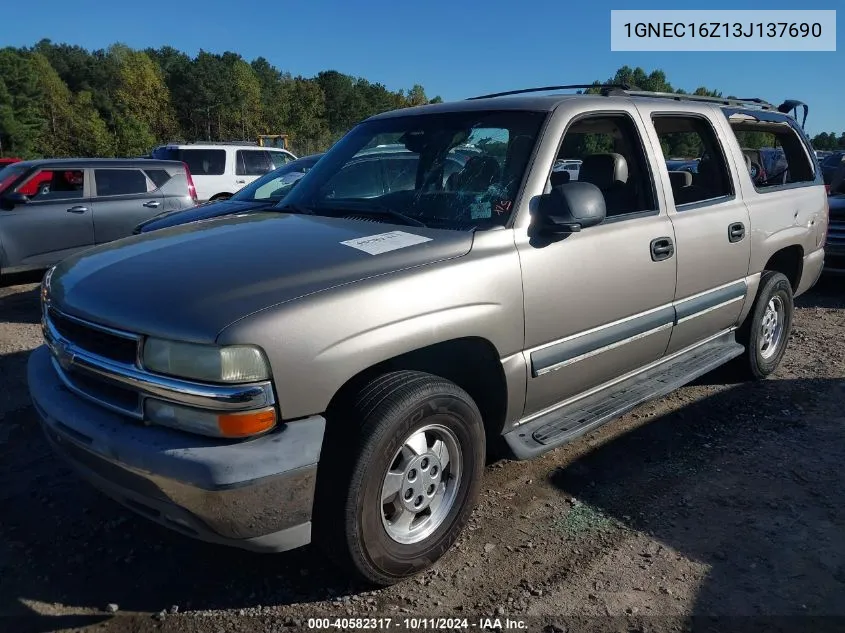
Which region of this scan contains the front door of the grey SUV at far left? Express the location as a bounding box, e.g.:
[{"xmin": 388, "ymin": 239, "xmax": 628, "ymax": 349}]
[{"xmin": 0, "ymin": 167, "xmax": 94, "ymax": 272}]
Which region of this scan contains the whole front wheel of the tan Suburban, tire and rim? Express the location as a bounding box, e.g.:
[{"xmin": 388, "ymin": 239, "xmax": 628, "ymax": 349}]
[{"xmin": 314, "ymin": 371, "xmax": 485, "ymax": 586}]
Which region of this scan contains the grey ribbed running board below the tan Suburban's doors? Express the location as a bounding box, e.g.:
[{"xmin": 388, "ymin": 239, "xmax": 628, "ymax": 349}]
[{"xmin": 504, "ymin": 332, "xmax": 745, "ymax": 459}]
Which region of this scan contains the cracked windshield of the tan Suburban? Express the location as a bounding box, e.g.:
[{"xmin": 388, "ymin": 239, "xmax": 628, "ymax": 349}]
[{"xmin": 282, "ymin": 111, "xmax": 547, "ymax": 229}]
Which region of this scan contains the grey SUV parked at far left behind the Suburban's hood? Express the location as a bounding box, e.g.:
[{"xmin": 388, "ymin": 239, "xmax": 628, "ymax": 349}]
[{"xmin": 0, "ymin": 158, "xmax": 196, "ymax": 274}]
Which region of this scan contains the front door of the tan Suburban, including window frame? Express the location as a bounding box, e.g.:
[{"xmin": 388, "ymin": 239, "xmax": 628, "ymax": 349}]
[{"xmin": 515, "ymin": 104, "xmax": 677, "ymax": 416}]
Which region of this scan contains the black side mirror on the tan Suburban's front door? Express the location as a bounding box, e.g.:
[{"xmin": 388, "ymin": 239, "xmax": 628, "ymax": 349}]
[{"xmin": 534, "ymin": 181, "xmax": 607, "ymax": 235}]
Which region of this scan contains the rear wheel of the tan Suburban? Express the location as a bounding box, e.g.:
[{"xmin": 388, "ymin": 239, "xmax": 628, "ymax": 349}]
[{"xmin": 736, "ymin": 270, "xmax": 794, "ymax": 380}]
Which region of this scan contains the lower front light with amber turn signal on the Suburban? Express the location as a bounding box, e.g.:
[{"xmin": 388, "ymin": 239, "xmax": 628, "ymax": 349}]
[{"xmin": 145, "ymin": 398, "xmax": 276, "ymax": 438}]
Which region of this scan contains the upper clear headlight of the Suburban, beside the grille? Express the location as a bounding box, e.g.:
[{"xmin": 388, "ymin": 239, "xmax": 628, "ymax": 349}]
[{"xmin": 142, "ymin": 338, "xmax": 270, "ymax": 383}]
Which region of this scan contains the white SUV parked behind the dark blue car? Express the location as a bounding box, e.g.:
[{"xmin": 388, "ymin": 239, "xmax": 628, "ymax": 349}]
[{"xmin": 151, "ymin": 143, "xmax": 296, "ymax": 202}]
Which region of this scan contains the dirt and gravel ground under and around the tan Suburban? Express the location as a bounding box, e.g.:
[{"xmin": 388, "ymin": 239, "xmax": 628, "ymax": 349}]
[{"xmin": 0, "ymin": 272, "xmax": 845, "ymax": 633}]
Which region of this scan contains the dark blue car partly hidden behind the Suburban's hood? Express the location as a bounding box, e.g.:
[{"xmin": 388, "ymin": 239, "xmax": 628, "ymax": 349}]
[{"xmin": 133, "ymin": 154, "xmax": 322, "ymax": 234}]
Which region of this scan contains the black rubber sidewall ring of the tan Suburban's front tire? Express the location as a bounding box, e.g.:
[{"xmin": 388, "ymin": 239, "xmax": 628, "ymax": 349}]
[{"xmin": 347, "ymin": 393, "xmax": 485, "ymax": 583}]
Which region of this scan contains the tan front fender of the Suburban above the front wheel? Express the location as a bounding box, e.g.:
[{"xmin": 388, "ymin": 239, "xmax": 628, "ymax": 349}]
[{"xmin": 218, "ymin": 231, "xmax": 524, "ymax": 419}]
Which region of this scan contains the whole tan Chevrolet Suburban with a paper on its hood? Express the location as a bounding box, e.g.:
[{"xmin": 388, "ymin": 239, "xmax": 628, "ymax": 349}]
[{"xmin": 28, "ymin": 86, "xmax": 828, "ymax": 585}]
